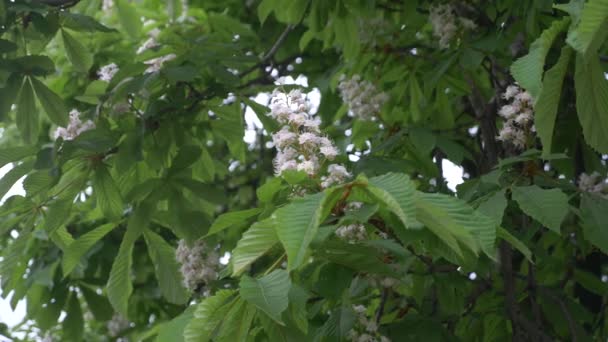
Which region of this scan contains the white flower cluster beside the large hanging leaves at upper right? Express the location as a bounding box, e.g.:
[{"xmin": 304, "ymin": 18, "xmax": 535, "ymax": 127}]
[{"xmin": 497, "ymin": 85, "xmax": 534, "ymax": 149}]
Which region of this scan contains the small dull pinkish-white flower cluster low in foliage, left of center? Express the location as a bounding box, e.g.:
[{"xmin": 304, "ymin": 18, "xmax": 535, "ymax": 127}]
[{"xmin": 175, "ymin": 240, "xmax": 220, "ymax": 291}]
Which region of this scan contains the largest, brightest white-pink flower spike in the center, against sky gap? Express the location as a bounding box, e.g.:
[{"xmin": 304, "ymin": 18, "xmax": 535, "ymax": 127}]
[{"xmin": 269, "ymin": 89, "xmax": 346, "ymax": 179}]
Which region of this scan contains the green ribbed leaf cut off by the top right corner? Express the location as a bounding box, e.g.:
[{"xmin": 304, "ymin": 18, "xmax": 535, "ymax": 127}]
[{"xmin": 566, "ymin": 0, "xmax": 608, "ymax": 54}]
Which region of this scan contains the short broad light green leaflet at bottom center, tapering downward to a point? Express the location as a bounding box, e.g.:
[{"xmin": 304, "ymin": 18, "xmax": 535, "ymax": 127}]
[{"xmin": 239, "ymin": 270, "xmax": 291, "ymax": 324}]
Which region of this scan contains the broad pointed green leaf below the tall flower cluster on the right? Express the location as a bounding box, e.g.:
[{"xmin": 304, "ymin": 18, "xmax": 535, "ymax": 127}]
[{"xmin": 511, "ymin": 185, "xmax": 569, "ymax": 234}]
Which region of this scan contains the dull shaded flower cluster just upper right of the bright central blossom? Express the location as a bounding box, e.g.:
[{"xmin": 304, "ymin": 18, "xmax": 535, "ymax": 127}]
[{"xmin": 338, "ymin": 75, "xmax": 388, "ymax": 120}]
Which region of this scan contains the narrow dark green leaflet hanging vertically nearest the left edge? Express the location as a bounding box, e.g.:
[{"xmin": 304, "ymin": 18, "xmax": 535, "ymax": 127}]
[{"xmin": 16, "ymin": 78, "xmax": 39, "ymax": 143}]
